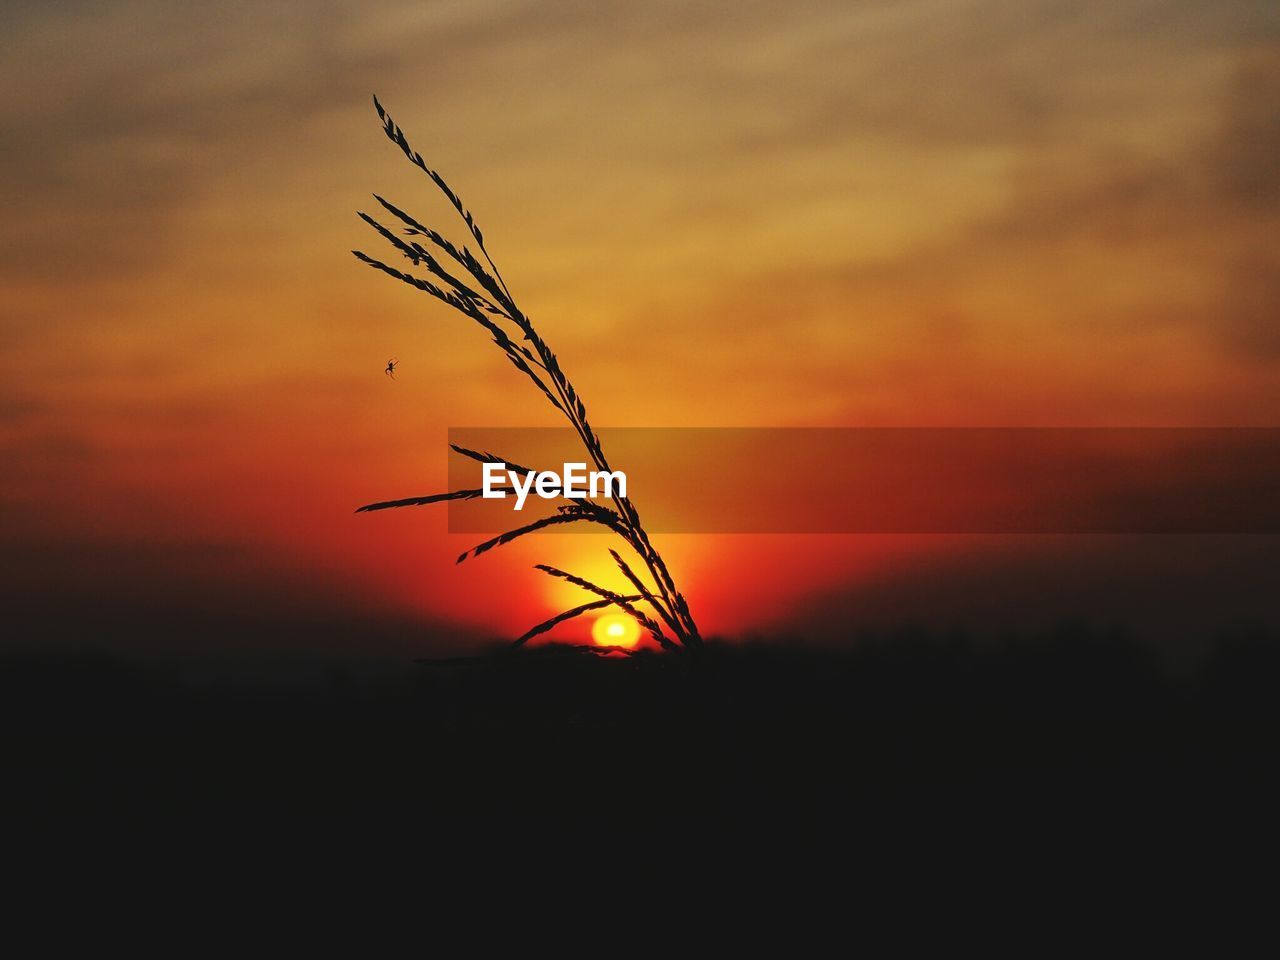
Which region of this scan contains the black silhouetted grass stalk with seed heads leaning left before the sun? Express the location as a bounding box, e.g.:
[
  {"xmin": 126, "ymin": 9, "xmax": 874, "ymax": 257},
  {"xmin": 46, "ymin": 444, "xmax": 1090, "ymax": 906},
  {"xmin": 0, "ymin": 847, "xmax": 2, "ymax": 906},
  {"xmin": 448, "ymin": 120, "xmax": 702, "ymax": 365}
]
[{"xmin": 352, "ymin": 97, "xmax": 701, "ymax": 650}]
